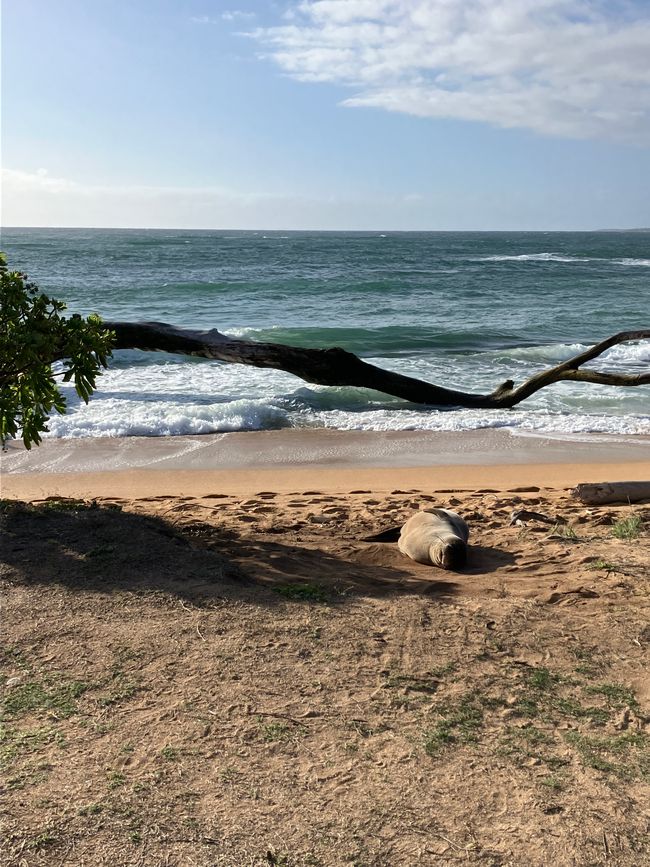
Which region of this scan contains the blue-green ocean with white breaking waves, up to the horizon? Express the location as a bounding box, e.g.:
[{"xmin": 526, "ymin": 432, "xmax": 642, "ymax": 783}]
[{"xmin": 2, "ymin": 228, "xmax": 650, "ymax": 437}]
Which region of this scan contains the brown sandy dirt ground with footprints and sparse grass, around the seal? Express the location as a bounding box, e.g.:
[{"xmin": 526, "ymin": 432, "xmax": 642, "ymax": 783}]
[{"xmin": 0, "ymin": 489, "xmax": 650, "ymax": 867}]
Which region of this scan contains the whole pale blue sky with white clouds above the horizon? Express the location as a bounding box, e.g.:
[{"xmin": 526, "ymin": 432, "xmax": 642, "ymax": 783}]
[{"xmin": 2, "ymin": 0, "xmax": 650, "ymax": 230}]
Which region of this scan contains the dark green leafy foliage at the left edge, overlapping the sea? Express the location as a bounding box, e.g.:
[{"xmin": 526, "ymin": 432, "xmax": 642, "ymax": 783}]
[{"xmin": 0, "ymin": 253, "xmax": 112, "ymax": 449}]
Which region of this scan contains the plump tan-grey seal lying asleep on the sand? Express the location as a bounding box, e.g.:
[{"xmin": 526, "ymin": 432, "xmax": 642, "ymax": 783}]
[{"xmin": 397, "ymin": 509, "xmax": 469, "ymax": 569}]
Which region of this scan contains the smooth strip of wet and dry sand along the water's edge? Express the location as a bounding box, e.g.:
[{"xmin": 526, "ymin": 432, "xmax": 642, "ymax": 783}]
[{"xmin": 0, "ymin": 429, "xmax": 650, "ymax": 499}]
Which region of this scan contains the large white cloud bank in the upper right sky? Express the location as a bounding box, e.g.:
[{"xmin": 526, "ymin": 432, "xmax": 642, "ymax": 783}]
[{"xmin": 249, "ymin": 0, "xmax": 650, "ymax": 144}]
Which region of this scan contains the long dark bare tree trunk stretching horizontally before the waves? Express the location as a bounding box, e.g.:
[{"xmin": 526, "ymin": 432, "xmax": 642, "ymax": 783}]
[{"xmin": 104, "ymin": 322, "xmax": 650, "ymax": 409}]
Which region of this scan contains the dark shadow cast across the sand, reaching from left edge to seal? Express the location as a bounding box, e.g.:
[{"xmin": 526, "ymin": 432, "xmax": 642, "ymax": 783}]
[{"xmin": 0, "ymin": 500, "xmax": 513, "ymax": 605}]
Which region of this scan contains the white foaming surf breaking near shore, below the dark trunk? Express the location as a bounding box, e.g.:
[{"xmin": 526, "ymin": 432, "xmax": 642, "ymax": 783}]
[{"xmin": 39, "ymin": 341, "xmax": 650, "ymax": 437}]
